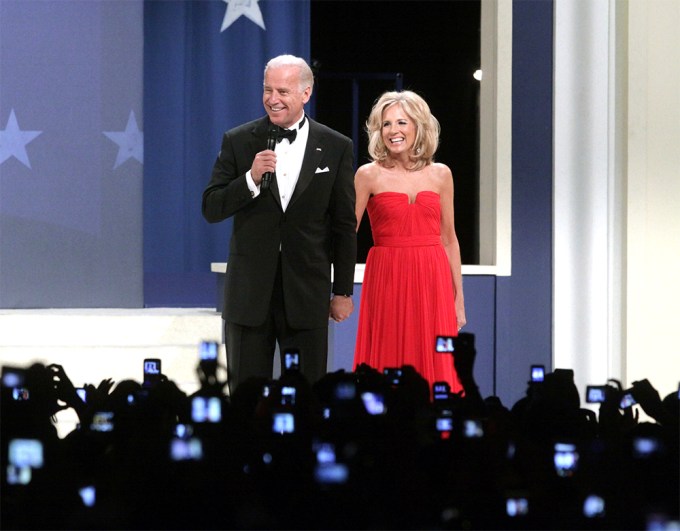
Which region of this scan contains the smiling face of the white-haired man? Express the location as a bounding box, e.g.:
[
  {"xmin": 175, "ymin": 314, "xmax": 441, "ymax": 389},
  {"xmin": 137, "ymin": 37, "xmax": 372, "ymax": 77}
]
[{"xmin": 262, "ymin": 66, "xmax": 312, "ymax": 129}]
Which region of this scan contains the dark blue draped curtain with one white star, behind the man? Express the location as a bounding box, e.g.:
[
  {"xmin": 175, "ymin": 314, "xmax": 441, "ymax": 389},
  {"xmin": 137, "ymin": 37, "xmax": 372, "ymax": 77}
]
[{"xmin": 144, "ymin": 0, "xmax": 310, "ymax": 307}]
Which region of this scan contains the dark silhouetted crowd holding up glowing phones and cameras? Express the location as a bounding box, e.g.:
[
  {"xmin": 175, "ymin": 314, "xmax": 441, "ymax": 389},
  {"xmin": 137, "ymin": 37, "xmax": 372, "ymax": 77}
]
[{"xmin": 0, "ymin": 334, "xmax": 680, "ymax": 530}]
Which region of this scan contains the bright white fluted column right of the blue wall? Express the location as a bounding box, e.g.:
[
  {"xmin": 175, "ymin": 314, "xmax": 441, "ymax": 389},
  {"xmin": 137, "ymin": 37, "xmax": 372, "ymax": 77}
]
[{"xmin": 553, "ymin": 0, "xmax": 622, "ymax": 398}]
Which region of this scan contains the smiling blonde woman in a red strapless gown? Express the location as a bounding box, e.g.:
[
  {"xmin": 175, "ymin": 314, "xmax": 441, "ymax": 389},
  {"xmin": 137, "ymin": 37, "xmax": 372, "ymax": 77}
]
[{"xmin": 354, "ymin": 91, "xmax": 465, "ymax": 392}]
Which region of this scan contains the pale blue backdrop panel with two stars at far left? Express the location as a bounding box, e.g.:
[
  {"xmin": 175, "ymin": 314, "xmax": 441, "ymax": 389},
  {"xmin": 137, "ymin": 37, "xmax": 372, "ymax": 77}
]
[{"xmin": 0, "ymin": 0, "xmax": 144, "ymax": 308}]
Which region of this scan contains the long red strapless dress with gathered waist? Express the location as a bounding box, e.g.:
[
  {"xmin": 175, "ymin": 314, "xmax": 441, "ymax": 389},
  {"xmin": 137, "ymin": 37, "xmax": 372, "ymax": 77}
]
[{"xmin": 354, "ymin": 191, "xmax": 462, "ymax": 392}]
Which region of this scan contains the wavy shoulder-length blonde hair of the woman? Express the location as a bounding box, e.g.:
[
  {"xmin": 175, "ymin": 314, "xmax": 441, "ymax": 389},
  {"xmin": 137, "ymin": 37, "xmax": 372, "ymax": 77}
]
[{"xmin": 366, "ymin": 90, "xmax": 440, "ymax": 170}]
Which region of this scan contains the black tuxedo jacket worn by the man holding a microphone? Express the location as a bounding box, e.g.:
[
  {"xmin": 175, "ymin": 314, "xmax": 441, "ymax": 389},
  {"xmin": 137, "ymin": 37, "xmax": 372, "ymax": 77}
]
[{"xmin": 203, "ymin": 116, "xmax": 356, "ymax": 329}]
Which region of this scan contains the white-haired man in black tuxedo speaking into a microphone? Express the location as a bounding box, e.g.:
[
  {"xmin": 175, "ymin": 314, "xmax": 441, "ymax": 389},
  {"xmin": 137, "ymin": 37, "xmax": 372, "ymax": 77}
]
[{"xmin": 203, "ymin": 55, "xmax": 356, "ymax": 393}]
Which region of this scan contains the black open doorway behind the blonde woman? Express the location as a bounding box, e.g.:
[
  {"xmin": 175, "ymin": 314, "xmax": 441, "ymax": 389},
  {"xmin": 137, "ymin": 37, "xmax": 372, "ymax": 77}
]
[{"xmin": 311, "ymin": 0, "xmax": 481, "ymax": 264}]
